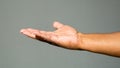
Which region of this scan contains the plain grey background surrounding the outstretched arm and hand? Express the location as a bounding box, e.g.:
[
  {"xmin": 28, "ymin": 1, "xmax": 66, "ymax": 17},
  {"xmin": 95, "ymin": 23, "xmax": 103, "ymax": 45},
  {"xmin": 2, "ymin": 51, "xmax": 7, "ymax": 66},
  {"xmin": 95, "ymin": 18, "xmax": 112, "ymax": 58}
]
[{"xmin": 0, "ymin": 0, "xmax": 120, "ymax": 68}]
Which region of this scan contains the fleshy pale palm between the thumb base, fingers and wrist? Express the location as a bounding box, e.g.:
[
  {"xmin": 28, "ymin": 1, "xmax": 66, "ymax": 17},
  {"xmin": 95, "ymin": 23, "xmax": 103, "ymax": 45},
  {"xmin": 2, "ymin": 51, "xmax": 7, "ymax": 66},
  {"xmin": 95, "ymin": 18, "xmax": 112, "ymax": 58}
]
[{"xmin": 53, "ymin": 25, "xmax": 78, "ymax": 49}]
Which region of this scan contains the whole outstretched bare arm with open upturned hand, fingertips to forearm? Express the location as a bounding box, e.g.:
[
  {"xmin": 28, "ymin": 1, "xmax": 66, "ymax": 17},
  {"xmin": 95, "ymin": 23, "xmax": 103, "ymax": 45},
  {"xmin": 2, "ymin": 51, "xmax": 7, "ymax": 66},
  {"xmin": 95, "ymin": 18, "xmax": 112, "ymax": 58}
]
[{"xmin": 20, "ymin": 22, "xmax": 120, "ymax": 57}]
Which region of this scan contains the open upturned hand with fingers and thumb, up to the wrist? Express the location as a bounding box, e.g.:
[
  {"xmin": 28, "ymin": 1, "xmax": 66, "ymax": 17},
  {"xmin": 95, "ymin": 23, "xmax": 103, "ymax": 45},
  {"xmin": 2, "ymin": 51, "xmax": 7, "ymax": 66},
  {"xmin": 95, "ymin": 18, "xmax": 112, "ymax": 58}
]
[{"xmin": 21, "ymin": 22, "xmax": 80, "ymax": 49}]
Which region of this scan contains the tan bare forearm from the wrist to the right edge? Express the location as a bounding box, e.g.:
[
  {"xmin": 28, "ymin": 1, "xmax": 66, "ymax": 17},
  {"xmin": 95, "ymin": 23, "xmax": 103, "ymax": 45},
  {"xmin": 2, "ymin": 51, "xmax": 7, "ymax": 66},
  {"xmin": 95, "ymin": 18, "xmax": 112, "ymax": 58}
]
[{"xmin": 79, "ymin": 33, "xmax": 120, "ymax": 57}]
